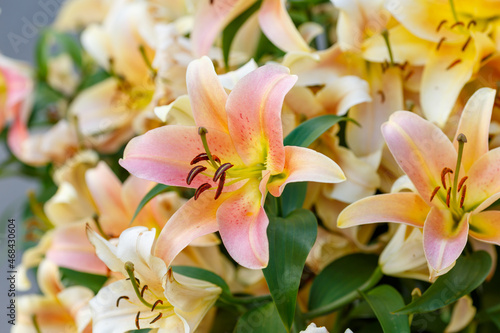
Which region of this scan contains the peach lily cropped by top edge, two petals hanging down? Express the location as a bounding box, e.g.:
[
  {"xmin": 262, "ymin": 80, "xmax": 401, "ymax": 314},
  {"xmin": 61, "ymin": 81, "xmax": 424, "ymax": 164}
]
[{"xmin": 191, "ymin": 0, "xmax": 310, "ymax": 56}]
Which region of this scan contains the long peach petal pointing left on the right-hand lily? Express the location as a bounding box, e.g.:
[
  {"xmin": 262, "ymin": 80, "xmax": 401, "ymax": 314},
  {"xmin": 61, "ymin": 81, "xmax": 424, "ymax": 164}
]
[{"xmin": 337, "ymin": 193, "xmax": 430, "ymax": 228}]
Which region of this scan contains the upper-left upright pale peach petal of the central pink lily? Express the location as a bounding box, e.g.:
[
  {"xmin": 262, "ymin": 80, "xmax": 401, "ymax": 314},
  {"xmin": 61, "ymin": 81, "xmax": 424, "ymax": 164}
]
[{"xmin": 186, "ymin": 56, "xmax": 228, "ymax": 132}]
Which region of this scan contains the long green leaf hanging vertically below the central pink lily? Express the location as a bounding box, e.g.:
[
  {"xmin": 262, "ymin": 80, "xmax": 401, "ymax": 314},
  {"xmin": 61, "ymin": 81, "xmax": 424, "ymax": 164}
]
[{"xmin": 263, "ymin": 209, "xmax": 318, "ymax": 331}]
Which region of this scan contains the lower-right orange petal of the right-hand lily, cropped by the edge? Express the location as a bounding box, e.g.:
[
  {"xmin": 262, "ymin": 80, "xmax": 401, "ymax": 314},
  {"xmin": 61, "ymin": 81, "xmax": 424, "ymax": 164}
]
[{"xmin": 469, "ymin": 210, "xmax": 500, "ymax": 245}]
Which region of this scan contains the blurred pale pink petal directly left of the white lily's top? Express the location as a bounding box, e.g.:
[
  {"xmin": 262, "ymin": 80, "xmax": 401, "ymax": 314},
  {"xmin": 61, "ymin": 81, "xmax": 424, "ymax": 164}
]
[{"xmin": 46, "ymin": 223, "xmax": 108, "ymax": 275}]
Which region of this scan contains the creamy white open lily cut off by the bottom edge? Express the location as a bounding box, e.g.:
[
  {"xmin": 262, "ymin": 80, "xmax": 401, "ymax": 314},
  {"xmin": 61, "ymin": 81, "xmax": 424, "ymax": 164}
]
[{"xmin": 87, "ymin": 227, "xmax": 222, "ymax": 333}]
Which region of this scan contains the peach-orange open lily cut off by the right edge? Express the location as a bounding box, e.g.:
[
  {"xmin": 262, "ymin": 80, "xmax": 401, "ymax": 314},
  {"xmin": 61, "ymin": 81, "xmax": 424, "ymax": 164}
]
[{"xmin": 337, "ymin": 88, "xmax": 500, "ymax": 279}]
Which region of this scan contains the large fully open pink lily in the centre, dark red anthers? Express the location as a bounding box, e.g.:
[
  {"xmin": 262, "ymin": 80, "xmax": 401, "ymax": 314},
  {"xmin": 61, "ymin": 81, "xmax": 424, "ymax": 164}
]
[{"xmin": 120, "ymin": 57, "xmax": 345, "ymax": 269}]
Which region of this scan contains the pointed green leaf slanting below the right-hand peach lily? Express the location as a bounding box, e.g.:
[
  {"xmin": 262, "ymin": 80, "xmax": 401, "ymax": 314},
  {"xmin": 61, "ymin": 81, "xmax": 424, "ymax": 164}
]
[{"xmin": 397, "ymin": 251, "xmax": 491, "ymax": 314}]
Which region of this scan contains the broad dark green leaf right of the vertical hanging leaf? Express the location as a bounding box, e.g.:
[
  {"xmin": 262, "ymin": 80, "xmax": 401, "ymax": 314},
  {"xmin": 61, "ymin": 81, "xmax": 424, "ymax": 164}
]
[{"xmin": 307, "ymin": 253, "xmax": 382, "ymax": 318}]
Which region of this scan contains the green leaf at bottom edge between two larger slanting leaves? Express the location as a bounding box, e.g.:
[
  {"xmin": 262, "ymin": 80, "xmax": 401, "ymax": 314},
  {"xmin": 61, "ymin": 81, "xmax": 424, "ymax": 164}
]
[{"xmin": 360, "ymin": 285, "xmax": 410, "ymax": 333}]
